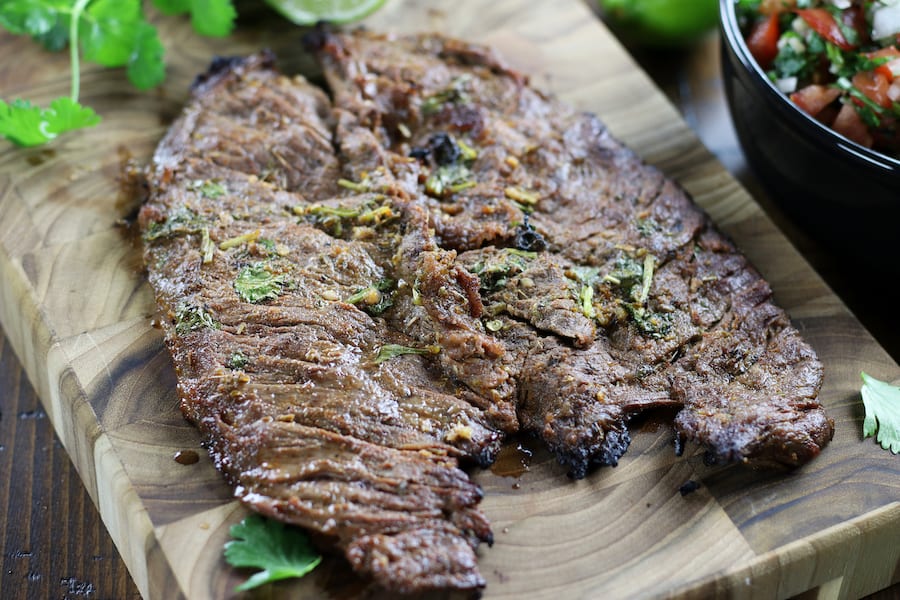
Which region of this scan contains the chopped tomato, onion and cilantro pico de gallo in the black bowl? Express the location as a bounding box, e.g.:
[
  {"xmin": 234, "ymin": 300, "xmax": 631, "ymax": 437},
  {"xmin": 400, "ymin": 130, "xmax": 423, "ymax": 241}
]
[{"xmin": 736, "ymin": 0, "xmax": 900, "ymax": 158}]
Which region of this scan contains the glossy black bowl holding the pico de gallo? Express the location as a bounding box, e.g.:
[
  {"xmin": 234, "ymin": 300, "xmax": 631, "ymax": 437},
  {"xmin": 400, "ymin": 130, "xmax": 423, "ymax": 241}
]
[{"xmin": 719, "ymin": 0, "xmax": 900, "ymax": 256}]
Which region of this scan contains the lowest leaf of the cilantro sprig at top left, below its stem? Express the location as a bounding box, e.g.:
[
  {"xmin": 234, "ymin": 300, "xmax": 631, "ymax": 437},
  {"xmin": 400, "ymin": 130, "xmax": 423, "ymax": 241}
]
[{"xmin": 0, "ymin": 97, "xmax": 100, "ymax": 146}]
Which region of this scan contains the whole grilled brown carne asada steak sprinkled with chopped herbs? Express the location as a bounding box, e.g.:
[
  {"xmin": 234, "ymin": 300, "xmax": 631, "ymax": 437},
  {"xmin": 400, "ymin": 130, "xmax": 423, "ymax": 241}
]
[{"xmin": 139, "ymin": 32, "xmax": 833, "ymax": 593}]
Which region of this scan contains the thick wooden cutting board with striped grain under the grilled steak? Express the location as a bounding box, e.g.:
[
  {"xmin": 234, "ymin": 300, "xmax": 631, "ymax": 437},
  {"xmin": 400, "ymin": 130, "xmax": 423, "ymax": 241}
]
[{"xmin": 0, "ymin": 0, "xmax": 900, "ymax": 599}]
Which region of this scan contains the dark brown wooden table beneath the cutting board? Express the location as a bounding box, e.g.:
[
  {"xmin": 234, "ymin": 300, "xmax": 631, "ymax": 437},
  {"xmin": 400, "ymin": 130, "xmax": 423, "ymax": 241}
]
[{"xmin": 0, "ymin": 25, "xmax": 900, "ymax": 600}]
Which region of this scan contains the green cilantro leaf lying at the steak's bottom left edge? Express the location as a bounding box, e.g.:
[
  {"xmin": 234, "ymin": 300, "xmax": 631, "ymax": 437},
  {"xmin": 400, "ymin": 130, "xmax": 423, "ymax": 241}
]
[{"xmin": 225, "ymin": 514, "xmax": 322, "ymax": 592}]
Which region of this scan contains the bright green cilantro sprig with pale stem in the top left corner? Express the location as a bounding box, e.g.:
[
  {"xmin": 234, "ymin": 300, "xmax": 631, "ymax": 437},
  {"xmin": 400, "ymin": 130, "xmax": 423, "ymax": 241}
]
[{"xmin": 0, "ymin": 0, "xmax": 237, "ymax": 146}]
